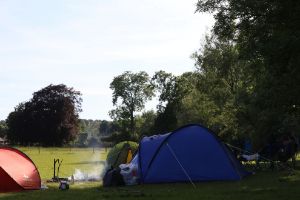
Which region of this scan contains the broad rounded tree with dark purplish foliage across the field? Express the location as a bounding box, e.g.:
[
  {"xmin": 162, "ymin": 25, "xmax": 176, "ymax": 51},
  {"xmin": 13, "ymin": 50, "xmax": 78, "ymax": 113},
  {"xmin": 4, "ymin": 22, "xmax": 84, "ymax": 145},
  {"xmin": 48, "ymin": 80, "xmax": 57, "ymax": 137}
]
[{"xmin": 7, "ymin": 84, "xmax": 82, "ymax": 146}]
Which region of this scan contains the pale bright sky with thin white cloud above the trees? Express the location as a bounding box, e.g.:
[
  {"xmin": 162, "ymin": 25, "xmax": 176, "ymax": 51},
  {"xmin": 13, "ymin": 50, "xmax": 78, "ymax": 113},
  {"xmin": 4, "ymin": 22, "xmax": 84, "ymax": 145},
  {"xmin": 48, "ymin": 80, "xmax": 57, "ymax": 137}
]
[{"xmin": 0, "ymin": 0, "xmax": 213, "ymax": 120}]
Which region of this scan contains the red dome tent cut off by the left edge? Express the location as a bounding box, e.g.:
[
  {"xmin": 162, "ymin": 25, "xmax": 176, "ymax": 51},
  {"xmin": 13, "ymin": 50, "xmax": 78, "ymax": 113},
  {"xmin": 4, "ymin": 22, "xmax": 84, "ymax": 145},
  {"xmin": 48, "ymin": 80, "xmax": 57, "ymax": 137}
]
[{"xmin": 0, "ymin": 147, "xmax": 41, "ymax": 192}]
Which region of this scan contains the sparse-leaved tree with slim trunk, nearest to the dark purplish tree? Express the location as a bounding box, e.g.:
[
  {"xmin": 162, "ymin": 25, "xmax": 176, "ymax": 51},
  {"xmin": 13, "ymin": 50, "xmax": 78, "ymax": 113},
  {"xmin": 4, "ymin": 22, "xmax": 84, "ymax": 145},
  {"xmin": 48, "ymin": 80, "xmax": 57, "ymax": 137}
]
[{"xmin": 110, "ymin": 71, "xmax": 154, "ymax": 138}]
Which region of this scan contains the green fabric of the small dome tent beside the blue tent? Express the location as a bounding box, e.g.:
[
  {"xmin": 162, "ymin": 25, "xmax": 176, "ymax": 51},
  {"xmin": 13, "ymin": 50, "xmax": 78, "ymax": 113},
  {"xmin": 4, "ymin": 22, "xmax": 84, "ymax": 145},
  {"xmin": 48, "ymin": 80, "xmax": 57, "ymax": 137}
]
[{"xmin": 106, "ymin": 141, "xmax": 139, "ymax": 168}]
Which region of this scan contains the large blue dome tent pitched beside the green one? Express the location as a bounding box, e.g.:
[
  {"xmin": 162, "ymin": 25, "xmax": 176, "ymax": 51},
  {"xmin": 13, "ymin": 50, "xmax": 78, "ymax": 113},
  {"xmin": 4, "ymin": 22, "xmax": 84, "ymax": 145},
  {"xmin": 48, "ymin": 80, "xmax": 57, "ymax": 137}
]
[{"xmin": 138, "ymin": 124, "xmax": 249, "ymax": 183}]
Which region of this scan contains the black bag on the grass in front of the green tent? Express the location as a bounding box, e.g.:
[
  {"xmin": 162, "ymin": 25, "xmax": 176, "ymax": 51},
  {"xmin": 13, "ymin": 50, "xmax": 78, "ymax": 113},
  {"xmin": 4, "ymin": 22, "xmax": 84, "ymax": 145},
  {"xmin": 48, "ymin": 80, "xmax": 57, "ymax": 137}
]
[{"xmin": 103, "ymin": 167, "xmax": 125, "ymax": 187}]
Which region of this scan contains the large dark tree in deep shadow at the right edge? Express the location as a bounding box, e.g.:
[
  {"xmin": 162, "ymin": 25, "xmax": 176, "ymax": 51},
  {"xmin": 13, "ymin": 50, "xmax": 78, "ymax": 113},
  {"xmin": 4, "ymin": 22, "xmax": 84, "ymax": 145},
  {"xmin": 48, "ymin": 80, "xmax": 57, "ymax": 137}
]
[{"xmin": 197, "ymin": 0, "xmax": 300, "ymax": 144}]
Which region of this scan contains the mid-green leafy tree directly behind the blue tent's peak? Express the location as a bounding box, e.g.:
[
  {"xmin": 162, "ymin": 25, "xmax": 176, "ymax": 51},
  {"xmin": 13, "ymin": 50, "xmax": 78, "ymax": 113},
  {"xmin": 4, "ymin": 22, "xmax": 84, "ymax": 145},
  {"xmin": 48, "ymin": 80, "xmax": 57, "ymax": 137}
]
[{"xmin": 191, "ymin": 35, "xmax": 253, "ymax": 139}]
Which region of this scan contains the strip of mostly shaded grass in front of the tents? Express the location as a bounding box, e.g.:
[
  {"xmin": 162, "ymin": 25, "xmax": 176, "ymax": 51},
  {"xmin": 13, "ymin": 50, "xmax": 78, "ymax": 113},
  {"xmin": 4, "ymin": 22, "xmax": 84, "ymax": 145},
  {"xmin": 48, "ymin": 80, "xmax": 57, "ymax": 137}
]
[{"xmin": 0, "ymin": 171, "xmax": 300, "ymax": 200}]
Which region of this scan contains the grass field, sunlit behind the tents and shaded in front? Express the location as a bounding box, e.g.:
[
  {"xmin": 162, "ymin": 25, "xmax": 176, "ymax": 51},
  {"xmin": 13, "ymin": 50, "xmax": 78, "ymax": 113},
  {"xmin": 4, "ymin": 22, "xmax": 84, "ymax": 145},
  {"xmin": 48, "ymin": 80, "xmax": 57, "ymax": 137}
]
[{"xmin": 0, "ymin": 148, "xmax": 300, "ymax": 200}]
